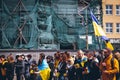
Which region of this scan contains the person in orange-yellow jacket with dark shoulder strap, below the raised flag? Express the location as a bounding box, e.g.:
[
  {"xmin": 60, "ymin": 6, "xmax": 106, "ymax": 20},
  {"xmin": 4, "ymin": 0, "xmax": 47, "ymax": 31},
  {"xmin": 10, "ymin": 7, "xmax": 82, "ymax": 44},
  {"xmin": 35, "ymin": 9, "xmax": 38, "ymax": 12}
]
[{"xmin": 100, "ymin": 48, "xmax": 119, "ymax": 80}]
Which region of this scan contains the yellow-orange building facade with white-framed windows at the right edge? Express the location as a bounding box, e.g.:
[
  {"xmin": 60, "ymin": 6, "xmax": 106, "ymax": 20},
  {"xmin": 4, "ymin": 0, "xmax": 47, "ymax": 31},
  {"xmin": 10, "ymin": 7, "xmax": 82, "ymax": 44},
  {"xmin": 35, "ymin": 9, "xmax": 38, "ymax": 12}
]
[{"xmin": 102, "ymin": 0, "xmax": 120, "ymax": 49}]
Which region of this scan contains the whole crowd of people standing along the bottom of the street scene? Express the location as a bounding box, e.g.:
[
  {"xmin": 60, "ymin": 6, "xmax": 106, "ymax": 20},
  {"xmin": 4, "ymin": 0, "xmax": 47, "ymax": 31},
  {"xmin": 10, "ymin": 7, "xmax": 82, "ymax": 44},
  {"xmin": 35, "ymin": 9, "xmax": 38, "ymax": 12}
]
[{"xmin": 0, "ymin": 48, "xmax": 120, "ymax": 80}]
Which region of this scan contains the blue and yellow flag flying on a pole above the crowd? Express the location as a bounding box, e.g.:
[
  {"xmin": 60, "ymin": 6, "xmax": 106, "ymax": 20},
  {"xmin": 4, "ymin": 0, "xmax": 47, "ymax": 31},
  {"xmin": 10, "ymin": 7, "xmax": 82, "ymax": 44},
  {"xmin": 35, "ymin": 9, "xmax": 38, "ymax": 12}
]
[{"xmin": 91, "ymin": 11, "xmax": 114, "ymax": 50}]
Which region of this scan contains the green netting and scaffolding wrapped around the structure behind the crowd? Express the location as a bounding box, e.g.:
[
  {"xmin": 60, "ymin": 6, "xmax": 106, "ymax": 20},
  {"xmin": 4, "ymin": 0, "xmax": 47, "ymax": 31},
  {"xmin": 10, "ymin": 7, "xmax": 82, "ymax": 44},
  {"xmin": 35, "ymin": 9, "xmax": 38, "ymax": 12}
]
[{"xmin": 0, "ymin": 0, "xmax": 102, "ymax": 50}]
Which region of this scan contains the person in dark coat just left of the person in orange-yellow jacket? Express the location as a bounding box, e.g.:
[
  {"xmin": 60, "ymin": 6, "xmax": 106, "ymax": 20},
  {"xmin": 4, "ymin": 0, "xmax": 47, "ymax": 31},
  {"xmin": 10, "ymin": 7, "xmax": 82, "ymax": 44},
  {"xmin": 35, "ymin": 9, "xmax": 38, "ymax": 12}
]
[{"xmin": 82, "ymin": 51, "xmax": 100, "ymax": 80}]
